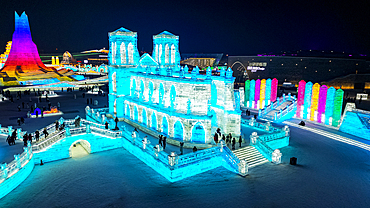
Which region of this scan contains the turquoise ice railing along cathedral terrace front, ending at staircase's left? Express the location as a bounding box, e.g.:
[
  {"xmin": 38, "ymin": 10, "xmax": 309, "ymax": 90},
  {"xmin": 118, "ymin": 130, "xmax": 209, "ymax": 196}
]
[{"xmin": 121, "ymin": 126, "xmax": 248, "ymax": 175}]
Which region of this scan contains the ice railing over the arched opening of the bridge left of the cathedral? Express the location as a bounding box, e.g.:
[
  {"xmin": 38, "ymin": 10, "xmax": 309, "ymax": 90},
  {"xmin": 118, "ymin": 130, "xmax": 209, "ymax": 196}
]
[{"xmin": 32, "ymin": 118, "xmax": 122, "ymax": 151}]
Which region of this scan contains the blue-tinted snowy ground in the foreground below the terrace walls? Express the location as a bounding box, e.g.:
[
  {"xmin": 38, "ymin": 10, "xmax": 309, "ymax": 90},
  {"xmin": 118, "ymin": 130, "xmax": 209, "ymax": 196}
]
[{"xmin": 0, "ymin": 87, "xmax": 370, "ymax": 208}]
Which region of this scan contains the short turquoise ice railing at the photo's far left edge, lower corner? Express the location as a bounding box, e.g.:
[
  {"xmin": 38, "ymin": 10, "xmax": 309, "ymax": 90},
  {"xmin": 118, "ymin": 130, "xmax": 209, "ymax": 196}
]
[{"xmin": 0, "ymin": 142, "xmax": 33, "ymax": 183}]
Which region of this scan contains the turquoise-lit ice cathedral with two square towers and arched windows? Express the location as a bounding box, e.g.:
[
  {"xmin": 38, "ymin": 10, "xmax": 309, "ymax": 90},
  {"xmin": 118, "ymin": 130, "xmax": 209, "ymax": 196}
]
[{"xmin": 108, "ymin": 28, "xmax": 241, "ymax": 143}]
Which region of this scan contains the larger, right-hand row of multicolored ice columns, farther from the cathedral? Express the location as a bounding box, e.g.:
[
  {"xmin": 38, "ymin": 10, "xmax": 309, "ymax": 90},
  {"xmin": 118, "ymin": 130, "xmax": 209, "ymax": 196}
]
[{"xmin": 296, "ymin": 80, "xmax": 344, "ymax": 127}]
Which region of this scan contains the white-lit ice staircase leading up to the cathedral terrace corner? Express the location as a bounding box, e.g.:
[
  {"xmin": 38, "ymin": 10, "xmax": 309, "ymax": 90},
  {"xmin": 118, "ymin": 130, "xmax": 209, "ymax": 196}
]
[{"xmin": 233, "ymin": 146, "xmax": 269, "ymax": 168}]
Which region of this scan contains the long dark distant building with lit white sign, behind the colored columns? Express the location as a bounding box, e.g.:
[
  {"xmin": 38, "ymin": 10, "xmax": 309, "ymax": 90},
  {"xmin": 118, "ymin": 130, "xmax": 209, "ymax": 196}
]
[{"xmin": 228, "ymin": 56, "xmax": 370, "ymax": 86}]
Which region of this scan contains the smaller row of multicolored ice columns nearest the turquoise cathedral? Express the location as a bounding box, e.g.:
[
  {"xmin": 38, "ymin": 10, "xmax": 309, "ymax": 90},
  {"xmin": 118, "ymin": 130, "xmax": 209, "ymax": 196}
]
[{"xmin": 244, "ymin": 78, "xmax": 278, "ymax": 109}]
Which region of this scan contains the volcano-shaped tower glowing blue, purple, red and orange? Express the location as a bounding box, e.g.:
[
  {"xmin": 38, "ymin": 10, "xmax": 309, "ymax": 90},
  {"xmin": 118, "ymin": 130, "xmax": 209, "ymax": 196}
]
[{"xmin": 0, "ymin": 12, "xmax": 75, "ymax": 85}]
